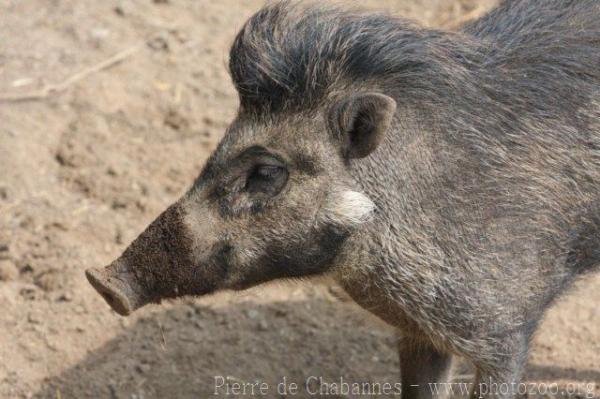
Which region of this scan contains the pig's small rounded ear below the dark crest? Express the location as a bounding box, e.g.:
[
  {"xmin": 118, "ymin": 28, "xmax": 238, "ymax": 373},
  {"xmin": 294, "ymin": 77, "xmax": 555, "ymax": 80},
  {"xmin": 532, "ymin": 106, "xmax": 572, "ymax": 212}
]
[{"xmin": 329, "ymin": 93, "xmax": 396, "ymax": 158}]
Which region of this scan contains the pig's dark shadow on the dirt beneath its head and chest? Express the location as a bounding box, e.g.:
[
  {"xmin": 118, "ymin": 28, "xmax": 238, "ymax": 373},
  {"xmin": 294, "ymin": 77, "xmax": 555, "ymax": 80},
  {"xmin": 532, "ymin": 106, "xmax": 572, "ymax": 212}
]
[{"xmin": 35, "ymin": 299, "xmax": 600, "ymax": 399}]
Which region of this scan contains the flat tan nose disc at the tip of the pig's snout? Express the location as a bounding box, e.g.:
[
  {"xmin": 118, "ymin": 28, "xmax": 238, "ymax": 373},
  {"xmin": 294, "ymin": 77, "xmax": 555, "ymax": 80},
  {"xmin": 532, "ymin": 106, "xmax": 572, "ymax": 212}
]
[{"xmin": 85, "ymin": 264, "xmax": 145, "ymax": 316}]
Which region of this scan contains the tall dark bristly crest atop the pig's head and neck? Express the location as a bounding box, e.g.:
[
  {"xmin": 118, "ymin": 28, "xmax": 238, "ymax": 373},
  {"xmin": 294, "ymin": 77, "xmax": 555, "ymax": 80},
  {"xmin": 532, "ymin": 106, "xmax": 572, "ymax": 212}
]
[{"xmin": 229, "ymin": 1, "xmax": 478, "ymax": 112}]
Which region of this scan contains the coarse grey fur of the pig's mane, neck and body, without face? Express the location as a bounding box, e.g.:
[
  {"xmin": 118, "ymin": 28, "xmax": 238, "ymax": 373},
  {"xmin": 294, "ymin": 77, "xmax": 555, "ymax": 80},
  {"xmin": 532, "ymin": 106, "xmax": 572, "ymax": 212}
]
[{"xmin": 230, "ymin": 0, "xmax": 600, "ymax": 388}]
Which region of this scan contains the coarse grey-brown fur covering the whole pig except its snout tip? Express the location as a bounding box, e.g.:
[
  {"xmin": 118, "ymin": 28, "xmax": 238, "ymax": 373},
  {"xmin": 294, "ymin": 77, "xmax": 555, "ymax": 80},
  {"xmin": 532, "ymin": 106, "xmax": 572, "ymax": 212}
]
[{"xmin": 90, "ymin": 0, "xmax": 600, "ymax": 398}]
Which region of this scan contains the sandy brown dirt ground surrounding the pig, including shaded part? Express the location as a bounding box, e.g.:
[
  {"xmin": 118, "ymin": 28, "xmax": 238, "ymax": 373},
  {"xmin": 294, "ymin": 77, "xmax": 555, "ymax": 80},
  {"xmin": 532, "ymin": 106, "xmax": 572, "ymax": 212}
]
[{"xmin": 0, "ymin": 0, "xmax": 600, "ymax": 399}]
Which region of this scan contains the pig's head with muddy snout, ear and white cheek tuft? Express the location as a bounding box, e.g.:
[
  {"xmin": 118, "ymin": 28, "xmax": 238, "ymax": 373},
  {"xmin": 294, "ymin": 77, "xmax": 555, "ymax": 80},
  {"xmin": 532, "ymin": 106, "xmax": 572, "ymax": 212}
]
[{"xmin": 86, "ymin": 3, "xmax": 396, "ymax": 315}]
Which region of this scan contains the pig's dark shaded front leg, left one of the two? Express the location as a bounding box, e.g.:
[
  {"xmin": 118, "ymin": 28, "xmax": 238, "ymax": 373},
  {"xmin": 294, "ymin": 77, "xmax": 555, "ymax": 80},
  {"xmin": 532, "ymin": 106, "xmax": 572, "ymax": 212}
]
[{"xmin": 398, "ymin": 337, "xmax": 452, "ymax": 399}]
